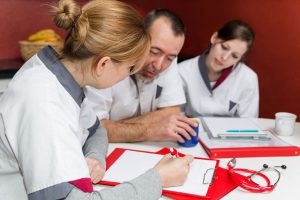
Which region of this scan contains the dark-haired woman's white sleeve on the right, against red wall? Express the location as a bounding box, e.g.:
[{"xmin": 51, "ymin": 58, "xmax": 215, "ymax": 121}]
[{"xmin": 238, "ymin": 74, "xmax": 259, "ymax": 117}]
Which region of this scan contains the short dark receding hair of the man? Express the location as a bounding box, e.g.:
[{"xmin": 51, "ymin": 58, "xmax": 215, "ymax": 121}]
[{"xmin": 144, "ymin": 8, "xmax": 185, "ymax": 36}]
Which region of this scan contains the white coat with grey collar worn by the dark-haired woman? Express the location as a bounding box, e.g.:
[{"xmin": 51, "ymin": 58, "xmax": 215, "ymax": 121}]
[{"xmin": 179, "ymin": 54, "xmax": 259, "ymax": 117}]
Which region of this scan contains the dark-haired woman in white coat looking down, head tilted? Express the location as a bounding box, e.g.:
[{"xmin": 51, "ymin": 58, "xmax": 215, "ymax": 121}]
[{"xmin": 179, "ymin": 20, "xmax": 259, "ymax": 117}]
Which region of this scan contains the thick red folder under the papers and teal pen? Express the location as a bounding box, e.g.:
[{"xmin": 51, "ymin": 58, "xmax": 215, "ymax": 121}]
[{"xmin": 199, "ymin": 138, "xmax": 300, "ymax": 158}]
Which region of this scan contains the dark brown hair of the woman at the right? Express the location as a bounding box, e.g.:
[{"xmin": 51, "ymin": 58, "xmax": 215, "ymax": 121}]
[{"xmin": 218, "ymin": 20, "xmax": 255, "ymax": 54}]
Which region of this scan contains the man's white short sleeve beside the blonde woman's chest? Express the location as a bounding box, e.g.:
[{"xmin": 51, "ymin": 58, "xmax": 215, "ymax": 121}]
[{"xmin": 84, "ymin": 86, "xmax": 112, "ymax": 120}]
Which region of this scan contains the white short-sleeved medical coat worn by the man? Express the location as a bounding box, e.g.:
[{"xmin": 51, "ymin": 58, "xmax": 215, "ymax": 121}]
[{"xmin": 85, "ymin": 59, "xmax": 185, "ymax": 120}]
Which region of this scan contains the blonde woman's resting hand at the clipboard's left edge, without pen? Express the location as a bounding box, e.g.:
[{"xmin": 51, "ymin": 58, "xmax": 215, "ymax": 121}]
[{"xmin": 85, "ymin": 157, "xmax": 105, "ymax": 183}]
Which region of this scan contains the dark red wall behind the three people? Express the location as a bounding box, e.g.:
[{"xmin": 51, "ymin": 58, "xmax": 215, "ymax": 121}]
[{"xmin": 0, "ymin": 0, "xmax": 300, "ymax": 121}]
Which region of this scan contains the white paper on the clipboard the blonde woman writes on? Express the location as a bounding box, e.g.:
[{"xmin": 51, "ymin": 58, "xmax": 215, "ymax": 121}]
[{"xmin": 102, "ymin": 150, "xmax": 216, "ymax": 196}]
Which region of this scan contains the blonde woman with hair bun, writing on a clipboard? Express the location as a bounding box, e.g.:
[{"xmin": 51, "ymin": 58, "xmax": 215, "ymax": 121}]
[{"xmin": 0, "ymin": 0, "xmax": 192, "ymax": 200}]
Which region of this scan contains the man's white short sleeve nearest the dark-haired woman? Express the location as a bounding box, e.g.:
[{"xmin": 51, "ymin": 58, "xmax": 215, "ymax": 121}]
[{"xmin": 158, "ymin": 59, "xmax": 186, "ymax": 108}]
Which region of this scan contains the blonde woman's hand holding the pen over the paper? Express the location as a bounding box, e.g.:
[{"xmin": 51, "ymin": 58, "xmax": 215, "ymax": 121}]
[{"xmin": 154, "ymin": 154, "xmax": 194, "ymax": 187}]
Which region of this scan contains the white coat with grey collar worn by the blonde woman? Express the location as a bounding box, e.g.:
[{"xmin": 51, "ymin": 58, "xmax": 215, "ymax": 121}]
[{"xmin": 0, "ymin": 47, "xmax": 99, "ymax": 200}]
